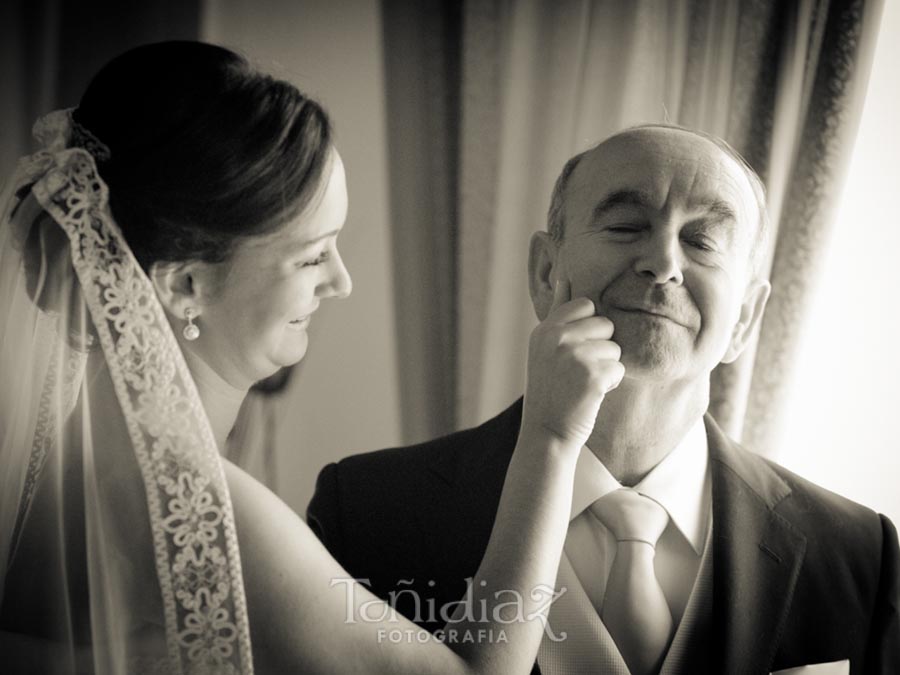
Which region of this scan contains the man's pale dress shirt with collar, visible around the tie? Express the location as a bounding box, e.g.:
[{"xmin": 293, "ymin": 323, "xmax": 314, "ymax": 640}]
[{"xmin": 565, "ymin": 418, "xmax": 712, "ymax": 626}]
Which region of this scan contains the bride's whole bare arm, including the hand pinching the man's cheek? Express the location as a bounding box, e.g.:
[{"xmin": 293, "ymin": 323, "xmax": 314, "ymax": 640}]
[{"xmin": 226, "ymin": 288, "xmax": 623, "ymax": 675}]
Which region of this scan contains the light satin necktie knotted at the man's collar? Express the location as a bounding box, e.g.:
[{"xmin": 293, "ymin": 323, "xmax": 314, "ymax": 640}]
[{"xmin": 591, "ymin": 489, "xmax": 672, "ymax": 675}]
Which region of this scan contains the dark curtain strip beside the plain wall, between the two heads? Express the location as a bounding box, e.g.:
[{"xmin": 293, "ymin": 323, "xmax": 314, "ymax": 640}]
[{"xmin": 382, "ymin": 0, "xmax": 462, "ymax": 442}]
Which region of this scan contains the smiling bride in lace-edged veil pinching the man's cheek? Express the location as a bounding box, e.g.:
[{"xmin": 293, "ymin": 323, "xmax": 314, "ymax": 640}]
[{"xmin": 0, "ymin": 42, "xmax": 621, "ymax": 674}]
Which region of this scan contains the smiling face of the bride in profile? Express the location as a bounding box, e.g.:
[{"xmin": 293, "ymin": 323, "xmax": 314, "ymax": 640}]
[{"xmin": 191, "ymin": 151, "xmax": 352, "ymax": 388}]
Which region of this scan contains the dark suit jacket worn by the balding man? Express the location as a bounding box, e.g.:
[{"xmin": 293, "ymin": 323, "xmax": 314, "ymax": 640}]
[{"xmin": 307, "ymin": 399, "xmax": 900, "ymax": 675}]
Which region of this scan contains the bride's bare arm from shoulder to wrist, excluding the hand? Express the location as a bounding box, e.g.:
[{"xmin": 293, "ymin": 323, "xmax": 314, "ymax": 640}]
[{"xmin": 226, "ymin": 434, "xmax": 574, "ymax": 675}]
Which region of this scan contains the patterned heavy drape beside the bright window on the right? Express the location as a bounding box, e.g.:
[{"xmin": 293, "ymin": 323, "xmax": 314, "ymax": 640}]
[{"xmin": 740, "ymin": 0, "xmax": 883, "ymax": 456}]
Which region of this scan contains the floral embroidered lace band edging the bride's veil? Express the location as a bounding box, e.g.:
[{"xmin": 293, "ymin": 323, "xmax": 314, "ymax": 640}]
[{"xmin": 24, "ymin": 111, "xmax": 253, "ymax": 675}]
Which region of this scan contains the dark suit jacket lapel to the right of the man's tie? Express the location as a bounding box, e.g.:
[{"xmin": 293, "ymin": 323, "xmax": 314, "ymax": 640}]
[{"xmin": 706, "ymin": 416, "xmax": 806, "ymax": 674}]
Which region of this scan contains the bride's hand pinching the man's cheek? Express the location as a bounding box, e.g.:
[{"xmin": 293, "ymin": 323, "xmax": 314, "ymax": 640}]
[{"xmin": 521, "ymin": 279, "xmax": 625, "ymax": 453}]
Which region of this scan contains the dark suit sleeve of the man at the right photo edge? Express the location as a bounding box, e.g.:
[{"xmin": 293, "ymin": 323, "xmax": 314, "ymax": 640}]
[{"xmin": 865, "ymin": 516, "xmax": 900, "ymax": 675}]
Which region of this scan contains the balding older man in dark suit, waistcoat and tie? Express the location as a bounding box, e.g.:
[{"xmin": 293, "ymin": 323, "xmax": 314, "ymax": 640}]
[{"xmin": 308, "ymin": 125, "xmax": 900, "ymax": 675}]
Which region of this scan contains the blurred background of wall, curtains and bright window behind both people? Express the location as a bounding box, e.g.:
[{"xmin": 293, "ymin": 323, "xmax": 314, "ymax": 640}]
[{"xmin": 0, "ymin": 0, "xmax": 900, "ymax": 522}]
